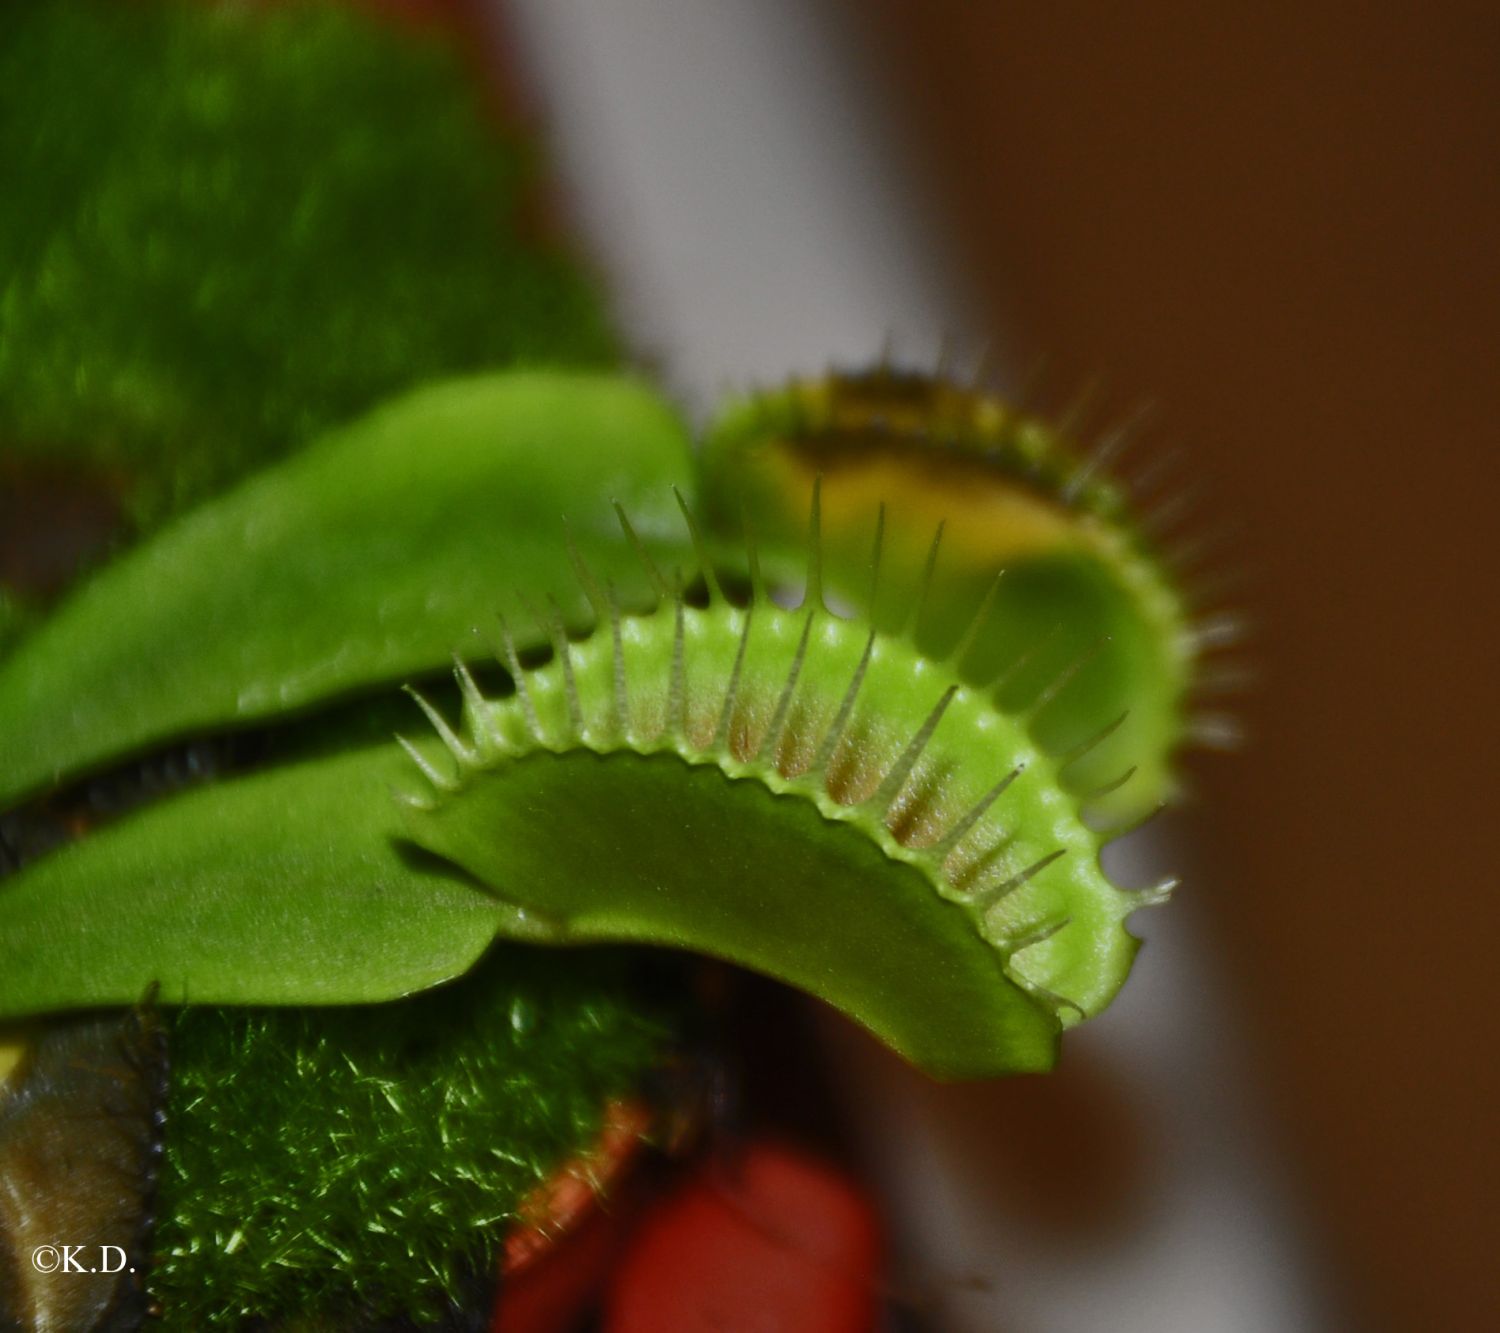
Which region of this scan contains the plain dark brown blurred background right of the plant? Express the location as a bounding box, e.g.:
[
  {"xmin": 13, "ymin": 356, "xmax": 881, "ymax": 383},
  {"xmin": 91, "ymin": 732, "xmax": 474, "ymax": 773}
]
[{"xmin": 851, "ymin": 0, "xmax": 1500, "ymax": 1330}]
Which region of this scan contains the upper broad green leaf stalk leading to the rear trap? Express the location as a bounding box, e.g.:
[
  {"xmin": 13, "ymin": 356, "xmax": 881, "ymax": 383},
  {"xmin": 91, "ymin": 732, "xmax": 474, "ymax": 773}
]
[{"xmin": 0, "ymin": 372, "xmax": 689, "ymax": 807}]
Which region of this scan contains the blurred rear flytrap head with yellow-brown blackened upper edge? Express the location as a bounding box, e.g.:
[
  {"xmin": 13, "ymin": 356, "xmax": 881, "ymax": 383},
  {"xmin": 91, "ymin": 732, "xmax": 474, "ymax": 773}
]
[{"xmin": 699, "ymin": 366, "xmax": 1197, "ymax": 819}]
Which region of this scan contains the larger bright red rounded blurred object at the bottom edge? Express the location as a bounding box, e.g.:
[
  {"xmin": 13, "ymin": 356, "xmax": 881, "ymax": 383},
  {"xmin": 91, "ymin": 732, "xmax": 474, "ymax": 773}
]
[{"xmin": 603, "ymin": 1144, "xmax": 881, "ymax": 1333}]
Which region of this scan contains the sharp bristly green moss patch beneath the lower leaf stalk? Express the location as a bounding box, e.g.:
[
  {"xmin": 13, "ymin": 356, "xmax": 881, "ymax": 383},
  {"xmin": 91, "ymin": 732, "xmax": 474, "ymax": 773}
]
[{"xmin": 150, "ymin": 949, "xmax": 666, "ymax": 1330}]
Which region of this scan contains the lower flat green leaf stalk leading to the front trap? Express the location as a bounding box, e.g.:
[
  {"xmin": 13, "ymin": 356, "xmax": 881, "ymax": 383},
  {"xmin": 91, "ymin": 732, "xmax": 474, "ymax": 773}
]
[{"xmin": 0, "ymin": 745, "xmax": 513, "ymax": 1017}]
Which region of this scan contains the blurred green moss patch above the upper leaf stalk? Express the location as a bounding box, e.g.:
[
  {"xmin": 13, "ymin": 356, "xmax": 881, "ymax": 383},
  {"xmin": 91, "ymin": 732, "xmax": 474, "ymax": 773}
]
[{"xmin": 0, "ymin": 0, "xmax": 614, "ymax": 523}]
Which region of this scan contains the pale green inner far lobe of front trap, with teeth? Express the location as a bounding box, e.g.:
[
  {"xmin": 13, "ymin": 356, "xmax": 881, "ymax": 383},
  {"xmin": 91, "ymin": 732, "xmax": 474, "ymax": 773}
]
[{"xmin": 402, "ymin": 494, "xmax": 1169, "ymax": 1012}]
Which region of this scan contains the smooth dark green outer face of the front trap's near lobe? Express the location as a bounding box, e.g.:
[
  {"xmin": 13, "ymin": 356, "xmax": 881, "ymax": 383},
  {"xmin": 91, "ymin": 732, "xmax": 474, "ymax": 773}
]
[{"xmin": 414, "ymin": 754, "xmax": 1059, "ymax": 1078}]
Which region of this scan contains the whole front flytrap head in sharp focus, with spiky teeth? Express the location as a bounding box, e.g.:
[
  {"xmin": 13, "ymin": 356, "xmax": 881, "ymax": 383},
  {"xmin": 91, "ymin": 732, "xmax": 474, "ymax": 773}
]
[{"xmin": 393, "ymin": 494, "xmax": 1160, "ymax": 1077}]
